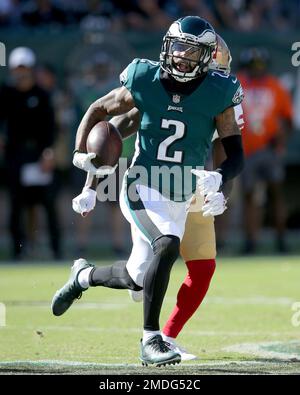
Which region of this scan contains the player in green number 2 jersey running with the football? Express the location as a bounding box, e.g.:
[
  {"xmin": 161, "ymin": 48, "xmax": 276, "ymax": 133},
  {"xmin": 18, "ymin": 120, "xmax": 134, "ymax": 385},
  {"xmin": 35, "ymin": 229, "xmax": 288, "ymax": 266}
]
[{"xmin": 52, "ymin": 16, "xmax": 243, "ymax": 366}]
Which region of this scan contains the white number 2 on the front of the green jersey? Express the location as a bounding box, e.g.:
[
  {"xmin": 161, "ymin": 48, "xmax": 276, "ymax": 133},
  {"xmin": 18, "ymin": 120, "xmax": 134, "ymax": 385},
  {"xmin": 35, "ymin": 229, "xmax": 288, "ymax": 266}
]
[{"xmin": 157, "ymin": 119, "xmax": 186, "ymax": 163}]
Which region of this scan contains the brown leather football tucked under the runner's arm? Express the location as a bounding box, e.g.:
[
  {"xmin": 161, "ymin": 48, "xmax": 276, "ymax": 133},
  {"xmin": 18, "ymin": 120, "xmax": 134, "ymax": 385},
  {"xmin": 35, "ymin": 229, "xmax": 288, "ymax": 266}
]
[{"xmin": 86, "ymin": 121, "xmax": 122, "ymax": 168}]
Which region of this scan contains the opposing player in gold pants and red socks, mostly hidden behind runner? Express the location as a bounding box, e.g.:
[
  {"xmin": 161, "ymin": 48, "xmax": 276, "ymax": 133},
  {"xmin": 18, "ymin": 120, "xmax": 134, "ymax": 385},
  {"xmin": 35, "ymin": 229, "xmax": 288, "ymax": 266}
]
[{"xmin": 107, "ymin": 34, "xmax": 244, "ymax": 361}]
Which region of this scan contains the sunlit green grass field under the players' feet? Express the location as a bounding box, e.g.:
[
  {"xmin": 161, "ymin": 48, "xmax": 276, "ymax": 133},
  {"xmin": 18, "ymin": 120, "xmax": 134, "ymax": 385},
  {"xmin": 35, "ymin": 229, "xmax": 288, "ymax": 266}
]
[{"xmin": 0, "ymin": 257, "xmax": 300, "ymax": 374}]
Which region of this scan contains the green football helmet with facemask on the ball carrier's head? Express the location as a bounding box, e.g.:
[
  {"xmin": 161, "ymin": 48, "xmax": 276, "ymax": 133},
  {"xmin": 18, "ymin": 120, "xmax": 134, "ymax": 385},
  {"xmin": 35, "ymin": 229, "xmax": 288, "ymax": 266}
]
[{"xmin": 160, "ymin": 16, "xmax": 217, "ymax": 82}]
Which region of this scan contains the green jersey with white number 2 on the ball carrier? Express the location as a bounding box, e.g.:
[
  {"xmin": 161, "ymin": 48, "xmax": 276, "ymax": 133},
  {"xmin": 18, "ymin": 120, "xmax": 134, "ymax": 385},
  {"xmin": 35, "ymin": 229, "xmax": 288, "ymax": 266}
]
[{"xmin": 120, "ymin": 59, "xmax": 242, "ymax": 201}]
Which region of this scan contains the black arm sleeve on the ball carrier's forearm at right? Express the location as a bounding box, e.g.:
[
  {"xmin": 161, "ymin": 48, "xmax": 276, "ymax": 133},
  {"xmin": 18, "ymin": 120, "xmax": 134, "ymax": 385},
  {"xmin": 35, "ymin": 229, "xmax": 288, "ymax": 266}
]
[{"xmin": 216, "ymin": 134, "xmax": 244, "ymax": 184}]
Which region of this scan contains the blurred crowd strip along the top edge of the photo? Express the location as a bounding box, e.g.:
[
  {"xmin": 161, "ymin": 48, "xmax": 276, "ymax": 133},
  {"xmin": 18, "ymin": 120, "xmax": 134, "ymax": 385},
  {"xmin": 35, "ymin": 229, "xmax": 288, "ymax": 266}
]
[{"xmin": 0, "ymin": 0, "xmax": 300, "ymax": 31}]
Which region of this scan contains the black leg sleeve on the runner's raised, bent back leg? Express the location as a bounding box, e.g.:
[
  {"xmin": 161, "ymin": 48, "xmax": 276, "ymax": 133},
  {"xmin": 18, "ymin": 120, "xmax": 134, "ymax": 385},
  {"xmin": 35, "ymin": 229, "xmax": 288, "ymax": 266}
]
[{"xmin": 89, "ymin": 261, "xmax": 143, "ymax": 291}]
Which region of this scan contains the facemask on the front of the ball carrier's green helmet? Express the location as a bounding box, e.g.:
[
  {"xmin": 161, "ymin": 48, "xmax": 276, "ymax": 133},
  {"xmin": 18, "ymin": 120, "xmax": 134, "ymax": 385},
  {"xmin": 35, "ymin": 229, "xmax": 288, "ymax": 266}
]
[{"xmin": 160, "ymin": 35, "xmax": 214, "ymax": 82}]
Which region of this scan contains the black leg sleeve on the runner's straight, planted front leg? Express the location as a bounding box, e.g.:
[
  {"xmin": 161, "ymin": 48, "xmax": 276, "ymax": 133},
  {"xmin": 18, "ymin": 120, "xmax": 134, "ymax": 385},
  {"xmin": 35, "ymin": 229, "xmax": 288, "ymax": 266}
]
[{"xmin": 144, "ymin": 235, "xmax": 180, "ymax": 331}]
